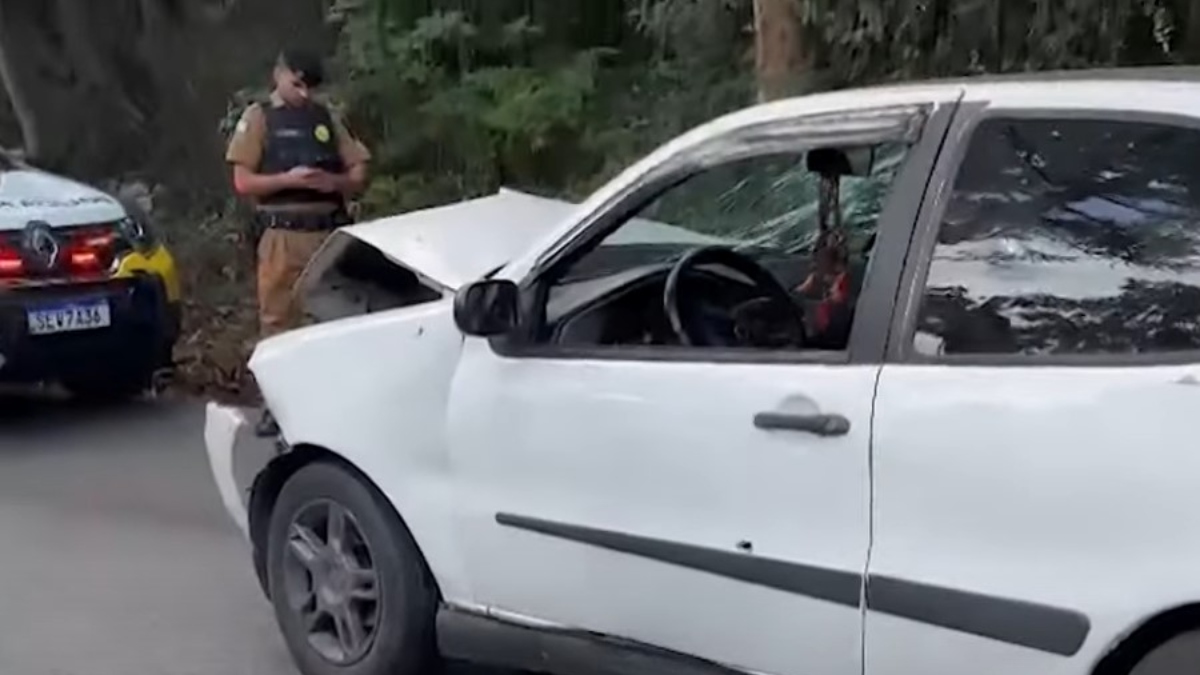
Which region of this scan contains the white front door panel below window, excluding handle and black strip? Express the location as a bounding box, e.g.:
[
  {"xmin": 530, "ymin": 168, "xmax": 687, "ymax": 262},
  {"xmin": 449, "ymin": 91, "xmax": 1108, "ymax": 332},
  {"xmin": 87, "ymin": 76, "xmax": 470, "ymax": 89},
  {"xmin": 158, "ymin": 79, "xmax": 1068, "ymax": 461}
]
[{"xmin": 446, "ymin": 340, "xmax": 877, "ymax": 673}]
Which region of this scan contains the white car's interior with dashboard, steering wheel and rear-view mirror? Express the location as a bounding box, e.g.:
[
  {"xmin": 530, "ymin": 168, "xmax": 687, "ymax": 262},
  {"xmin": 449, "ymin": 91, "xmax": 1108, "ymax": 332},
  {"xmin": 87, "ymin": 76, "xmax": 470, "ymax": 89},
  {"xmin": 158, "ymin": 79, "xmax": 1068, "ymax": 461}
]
[{"xmin": 541, "ymin": 142, "xmax": 876, "ymax": 351}]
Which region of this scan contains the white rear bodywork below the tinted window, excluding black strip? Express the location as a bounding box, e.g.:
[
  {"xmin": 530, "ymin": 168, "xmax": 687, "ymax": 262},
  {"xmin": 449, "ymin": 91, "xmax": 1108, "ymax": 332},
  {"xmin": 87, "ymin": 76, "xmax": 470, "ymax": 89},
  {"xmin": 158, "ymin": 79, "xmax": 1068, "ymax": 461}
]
[{"xmin": 866, "ymin": 364, "xmax": 1200, "ymax": 675}]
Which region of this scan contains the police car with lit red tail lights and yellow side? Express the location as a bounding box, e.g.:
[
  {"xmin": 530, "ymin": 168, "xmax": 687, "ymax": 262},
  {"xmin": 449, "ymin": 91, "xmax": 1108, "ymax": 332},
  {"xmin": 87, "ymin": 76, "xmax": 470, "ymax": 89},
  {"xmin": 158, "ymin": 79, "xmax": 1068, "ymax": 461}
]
[{"xmin": 0, "ymin": 155, "xmax": 180, "ymax": 398}]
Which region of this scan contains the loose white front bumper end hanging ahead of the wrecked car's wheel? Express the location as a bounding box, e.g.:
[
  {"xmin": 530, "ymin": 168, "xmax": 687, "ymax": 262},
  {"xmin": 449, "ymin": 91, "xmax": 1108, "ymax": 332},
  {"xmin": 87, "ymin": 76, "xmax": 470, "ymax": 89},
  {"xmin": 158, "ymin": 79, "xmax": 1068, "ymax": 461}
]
[{"xmin": 204, "ymin": 402, "xmax": 278, "ymax": 538}]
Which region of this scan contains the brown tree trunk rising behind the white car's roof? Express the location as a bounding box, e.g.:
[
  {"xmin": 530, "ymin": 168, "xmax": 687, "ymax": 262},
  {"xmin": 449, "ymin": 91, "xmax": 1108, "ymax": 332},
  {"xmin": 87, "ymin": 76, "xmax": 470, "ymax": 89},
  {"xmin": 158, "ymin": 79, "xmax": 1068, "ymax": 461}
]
[{"xmin": 754, "ymin": 0, "xmax": 810, "ymax": 101}]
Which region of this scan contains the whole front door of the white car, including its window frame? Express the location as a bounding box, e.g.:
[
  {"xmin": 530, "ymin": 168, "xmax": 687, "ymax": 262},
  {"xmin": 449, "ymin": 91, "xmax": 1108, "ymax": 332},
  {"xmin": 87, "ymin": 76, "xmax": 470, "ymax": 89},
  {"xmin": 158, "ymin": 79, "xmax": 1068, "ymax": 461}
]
[{"xmin": 448, "ymin": 101, "xmax": 950, "ymax": 675}]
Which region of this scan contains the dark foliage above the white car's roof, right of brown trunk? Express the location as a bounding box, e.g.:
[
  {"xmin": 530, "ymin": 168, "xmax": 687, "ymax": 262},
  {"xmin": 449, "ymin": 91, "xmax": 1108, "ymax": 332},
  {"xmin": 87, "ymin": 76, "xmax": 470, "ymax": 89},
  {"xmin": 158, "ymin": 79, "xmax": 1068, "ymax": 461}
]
[{"xmin": 796, "ymin": 0, "xmax": 1185, "ymax": 85}]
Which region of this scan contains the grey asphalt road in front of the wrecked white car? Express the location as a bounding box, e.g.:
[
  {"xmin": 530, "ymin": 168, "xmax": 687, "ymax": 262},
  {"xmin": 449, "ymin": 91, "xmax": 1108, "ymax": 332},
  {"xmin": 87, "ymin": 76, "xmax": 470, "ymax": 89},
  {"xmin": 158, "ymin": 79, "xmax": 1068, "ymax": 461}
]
[{"xmin": 0, "ymin": 394, "xmax": 516, "ymax": 675}]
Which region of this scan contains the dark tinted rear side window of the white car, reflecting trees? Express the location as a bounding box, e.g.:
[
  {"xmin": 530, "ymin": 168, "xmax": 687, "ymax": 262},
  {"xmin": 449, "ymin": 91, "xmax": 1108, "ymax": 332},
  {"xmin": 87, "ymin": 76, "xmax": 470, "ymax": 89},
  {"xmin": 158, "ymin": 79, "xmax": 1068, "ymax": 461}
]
[{"xmin": 914, "ymin": 119, "xmax": 1200, "ymax": 356}]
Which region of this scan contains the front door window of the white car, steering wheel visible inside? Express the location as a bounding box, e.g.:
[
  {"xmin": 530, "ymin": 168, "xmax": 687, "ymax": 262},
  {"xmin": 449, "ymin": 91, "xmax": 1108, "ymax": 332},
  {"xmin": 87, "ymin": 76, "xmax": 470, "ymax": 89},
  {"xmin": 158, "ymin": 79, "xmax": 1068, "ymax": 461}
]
[{"xmin": 544, "ymin": 144, "xmax": 908, "ymax": 351}]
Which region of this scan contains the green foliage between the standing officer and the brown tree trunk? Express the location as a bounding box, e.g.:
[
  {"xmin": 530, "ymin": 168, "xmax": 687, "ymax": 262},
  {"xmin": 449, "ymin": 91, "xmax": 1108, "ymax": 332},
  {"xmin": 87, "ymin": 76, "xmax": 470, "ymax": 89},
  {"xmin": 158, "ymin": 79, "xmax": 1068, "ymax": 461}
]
[{"xmin": 337, "ymin": 0, "xmax": 751, "ymax": 215}]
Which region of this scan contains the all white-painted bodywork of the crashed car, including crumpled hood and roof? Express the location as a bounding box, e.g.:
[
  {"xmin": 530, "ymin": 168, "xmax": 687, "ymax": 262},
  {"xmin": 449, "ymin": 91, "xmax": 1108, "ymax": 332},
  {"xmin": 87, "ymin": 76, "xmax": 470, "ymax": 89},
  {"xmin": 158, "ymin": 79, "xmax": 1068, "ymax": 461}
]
[{"xmin": 206, "ymin": 73, "xmax": 1200, "ymax": 675}]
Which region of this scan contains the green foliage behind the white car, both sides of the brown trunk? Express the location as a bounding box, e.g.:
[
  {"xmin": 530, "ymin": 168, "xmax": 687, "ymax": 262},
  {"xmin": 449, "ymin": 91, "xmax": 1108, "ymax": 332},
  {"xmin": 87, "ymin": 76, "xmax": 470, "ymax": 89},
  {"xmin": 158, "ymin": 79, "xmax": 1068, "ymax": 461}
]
[{"xmin": 309, "ymin": 0, "xmax": 1200, "ymax": 214}]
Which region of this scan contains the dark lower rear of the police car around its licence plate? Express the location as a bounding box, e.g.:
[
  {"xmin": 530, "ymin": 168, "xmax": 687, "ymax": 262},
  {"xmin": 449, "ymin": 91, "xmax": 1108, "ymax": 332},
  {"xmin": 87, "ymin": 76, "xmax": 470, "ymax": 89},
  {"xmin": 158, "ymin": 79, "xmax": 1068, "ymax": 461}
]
[{"xmin": 0, "ymin": 274, "xmax": 181, "ymax": 382}]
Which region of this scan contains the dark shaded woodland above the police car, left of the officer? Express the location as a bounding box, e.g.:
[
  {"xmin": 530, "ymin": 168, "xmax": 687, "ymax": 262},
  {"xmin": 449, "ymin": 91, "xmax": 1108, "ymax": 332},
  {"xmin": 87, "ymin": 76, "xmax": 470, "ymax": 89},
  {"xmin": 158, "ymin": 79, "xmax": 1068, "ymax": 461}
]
[{"xmin": 0, "ymin": 0, "xmax": 326, "ymax": 187}]
